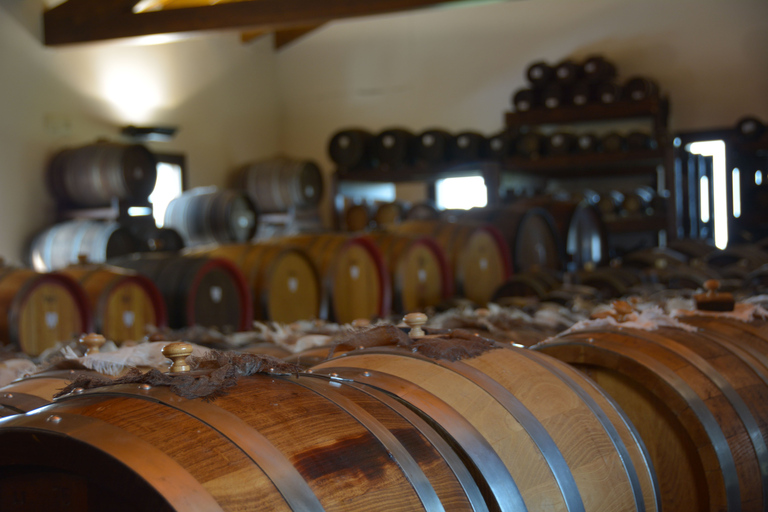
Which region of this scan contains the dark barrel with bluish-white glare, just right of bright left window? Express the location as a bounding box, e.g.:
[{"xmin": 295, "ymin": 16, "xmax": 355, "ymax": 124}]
[{"xmin": 165, "ymin": 188, "xmax": 258, "ymax": 246}]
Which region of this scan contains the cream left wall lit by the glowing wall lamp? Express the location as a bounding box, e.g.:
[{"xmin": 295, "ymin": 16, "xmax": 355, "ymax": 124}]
[{"xmin": 0, "ymin": 0, "xmax": 280, "ymax": 263}]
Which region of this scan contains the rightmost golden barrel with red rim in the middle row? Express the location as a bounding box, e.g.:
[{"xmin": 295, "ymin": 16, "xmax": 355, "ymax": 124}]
[{"xmin": 392, "ymin": 220, "xmax": 511, "ymax": 304}]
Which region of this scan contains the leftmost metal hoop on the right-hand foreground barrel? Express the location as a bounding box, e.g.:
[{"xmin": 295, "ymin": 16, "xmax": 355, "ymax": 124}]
[{"xmin": 547, "ymin": 331, "xmax": 741, "ymax": 512}]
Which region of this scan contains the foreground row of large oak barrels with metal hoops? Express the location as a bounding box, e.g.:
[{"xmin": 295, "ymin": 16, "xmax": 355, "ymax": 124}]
[{"xmin": 0, "ymin": 290, "xmax": 768, "ymax": 512}]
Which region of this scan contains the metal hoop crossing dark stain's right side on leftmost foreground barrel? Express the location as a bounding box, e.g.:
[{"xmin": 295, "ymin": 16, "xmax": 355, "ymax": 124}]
[{"xmin": 280, "ymin": 376, "xmax": 445, "ymax": 512}]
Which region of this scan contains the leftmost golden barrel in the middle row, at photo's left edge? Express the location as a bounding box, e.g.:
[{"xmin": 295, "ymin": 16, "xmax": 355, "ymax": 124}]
[{"xmin": 0, "ymin": 266, "xmax": 91, "ymax": 356}]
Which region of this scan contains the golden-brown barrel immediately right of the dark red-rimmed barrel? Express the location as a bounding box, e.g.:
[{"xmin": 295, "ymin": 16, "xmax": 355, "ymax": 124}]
[{"xmin": 193, "ymin": 243, "xmax": 323, "ymax": 323}]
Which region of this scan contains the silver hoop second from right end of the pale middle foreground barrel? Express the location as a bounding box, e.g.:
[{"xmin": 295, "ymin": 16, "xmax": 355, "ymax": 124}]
[{"xmin": 518, "ymin": 350, "xmax": 645, "ymax": 512}]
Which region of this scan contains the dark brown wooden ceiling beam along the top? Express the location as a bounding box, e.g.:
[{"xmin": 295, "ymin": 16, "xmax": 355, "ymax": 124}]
[{"xmin": 43, "ymin": 0, "xmax": 482, "ymax": 46}]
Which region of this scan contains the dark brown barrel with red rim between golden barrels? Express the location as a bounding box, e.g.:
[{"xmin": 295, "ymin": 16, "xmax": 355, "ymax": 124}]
[{"xmin": 110, "ymin": 253, "xmax": 253, "ymax": 332}]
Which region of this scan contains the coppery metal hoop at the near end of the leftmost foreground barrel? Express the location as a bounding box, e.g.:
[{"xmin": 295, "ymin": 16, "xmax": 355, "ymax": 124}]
[{"xmin": 0, "ymin": 405, "xmax": 222, "ymax": 512}]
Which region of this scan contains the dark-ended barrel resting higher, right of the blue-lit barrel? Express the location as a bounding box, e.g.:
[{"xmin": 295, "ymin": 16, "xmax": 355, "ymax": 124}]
[{"xmin": 232, "ymin": 158, "xmax": 323, "ymax": 213}]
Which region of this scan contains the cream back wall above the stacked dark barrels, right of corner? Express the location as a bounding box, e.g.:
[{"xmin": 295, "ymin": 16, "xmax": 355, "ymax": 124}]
[{"xmin": 278, "ymin": 0, "xmax": 768, "ymax": 222}]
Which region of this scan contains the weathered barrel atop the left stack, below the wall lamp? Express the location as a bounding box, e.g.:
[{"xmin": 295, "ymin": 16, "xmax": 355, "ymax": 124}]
[{"xmin": 47, "ymin": 141, "xmax": 157, "ymax": 206}]
